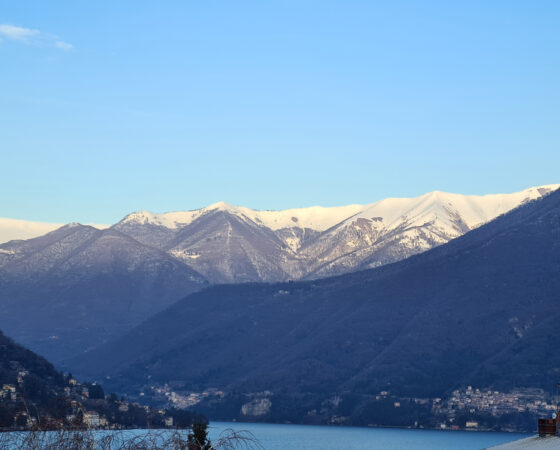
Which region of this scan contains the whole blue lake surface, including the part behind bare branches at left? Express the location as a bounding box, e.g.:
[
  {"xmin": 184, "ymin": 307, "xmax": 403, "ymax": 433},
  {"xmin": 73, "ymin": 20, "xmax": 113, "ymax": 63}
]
[{"xmin": 0, "ymin": 422, "xmax": 528, "ymax": 450}]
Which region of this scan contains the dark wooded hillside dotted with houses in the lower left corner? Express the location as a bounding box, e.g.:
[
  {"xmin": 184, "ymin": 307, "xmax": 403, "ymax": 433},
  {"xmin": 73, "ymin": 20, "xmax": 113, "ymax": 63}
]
[{"xmin": 0, "ymin": 331, "xmax": 201, "ymax": 430}]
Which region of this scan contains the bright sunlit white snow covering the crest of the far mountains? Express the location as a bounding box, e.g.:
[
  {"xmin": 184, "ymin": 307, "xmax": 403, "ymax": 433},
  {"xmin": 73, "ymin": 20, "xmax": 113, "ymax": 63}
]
[{"xmin": 121, "ymin": 184, "xmax": 560, "ymax": 234}]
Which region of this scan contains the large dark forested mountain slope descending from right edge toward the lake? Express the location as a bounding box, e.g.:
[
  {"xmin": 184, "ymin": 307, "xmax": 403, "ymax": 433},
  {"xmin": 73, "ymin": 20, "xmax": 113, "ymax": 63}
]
[{"xmin": 71, "ymin": 191, "xmax": 560, "ymax": 424}]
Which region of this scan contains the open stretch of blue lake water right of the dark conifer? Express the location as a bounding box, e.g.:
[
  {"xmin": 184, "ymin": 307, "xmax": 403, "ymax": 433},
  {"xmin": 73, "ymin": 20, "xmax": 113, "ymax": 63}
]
[{"xmin": 210, "ymin": 422, "xmax": 529, "ymax": 450}]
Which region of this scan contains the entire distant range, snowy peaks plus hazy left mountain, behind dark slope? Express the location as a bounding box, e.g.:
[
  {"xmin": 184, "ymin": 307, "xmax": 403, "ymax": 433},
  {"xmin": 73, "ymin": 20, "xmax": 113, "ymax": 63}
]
[{"xmin": 0, "ymin": 185, "xmax": 558, "ymax": 363}]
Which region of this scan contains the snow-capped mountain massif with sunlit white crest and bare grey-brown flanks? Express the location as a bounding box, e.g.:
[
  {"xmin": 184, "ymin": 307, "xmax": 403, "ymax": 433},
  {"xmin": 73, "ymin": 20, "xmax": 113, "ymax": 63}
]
[{"xmin": 114, "ymin": 185, "xmax": 560, "ymax": 282}]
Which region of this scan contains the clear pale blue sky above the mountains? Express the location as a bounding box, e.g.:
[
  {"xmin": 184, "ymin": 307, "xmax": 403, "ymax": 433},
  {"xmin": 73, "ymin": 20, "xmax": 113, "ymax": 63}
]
[{"xmin": 0, "ymin": 0, "xmax": 560, "ymax": 223}]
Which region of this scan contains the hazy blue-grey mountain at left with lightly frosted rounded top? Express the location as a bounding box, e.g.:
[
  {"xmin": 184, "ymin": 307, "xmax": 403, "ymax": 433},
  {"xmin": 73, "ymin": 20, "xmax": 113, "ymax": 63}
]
[{"xmin": 0, "ymin": 224, "xmax": 205, "ymax": 361}]
